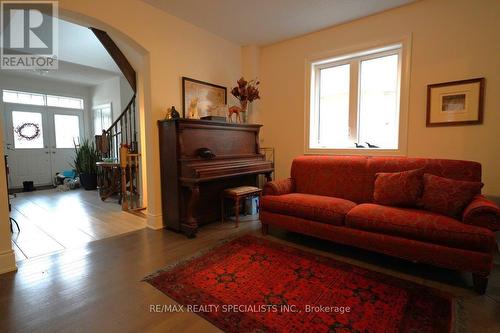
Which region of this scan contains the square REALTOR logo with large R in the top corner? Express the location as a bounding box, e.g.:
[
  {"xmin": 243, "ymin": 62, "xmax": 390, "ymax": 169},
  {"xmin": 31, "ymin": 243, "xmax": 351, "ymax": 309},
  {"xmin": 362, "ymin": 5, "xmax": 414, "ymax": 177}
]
[{"xmin": 0, "ymin": 1, "xmax": 58, "ymax": 69}]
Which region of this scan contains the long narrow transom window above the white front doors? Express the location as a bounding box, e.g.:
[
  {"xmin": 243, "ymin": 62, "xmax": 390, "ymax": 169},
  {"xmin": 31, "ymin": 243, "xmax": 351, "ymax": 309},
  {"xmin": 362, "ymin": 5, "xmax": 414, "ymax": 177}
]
[{"xmin": 3, "ymin": 90, "xmax": 83, "ymax": 110}]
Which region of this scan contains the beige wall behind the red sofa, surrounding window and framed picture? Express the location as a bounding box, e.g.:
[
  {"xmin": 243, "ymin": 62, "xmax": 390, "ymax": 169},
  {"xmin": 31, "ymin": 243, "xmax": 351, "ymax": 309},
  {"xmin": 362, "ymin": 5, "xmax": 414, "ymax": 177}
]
[{"xmin": 259, "ymin": 0, "xmax": 500, "ymax": 197}]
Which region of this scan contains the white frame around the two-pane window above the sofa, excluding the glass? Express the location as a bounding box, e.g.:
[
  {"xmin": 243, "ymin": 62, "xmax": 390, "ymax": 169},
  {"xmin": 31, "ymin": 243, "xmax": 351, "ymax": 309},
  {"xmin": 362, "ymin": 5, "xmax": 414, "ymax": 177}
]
[{"xmin": 304, "ymin": 35, "xmax": 411, "ymax": 156}]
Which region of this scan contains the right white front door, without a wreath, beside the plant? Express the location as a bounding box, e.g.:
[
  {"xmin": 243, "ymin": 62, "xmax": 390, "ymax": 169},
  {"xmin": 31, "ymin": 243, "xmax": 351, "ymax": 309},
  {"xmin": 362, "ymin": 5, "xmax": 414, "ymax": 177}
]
[{"xmin": 49, "ymin": 108, "xmax": 84, "ymax": 175}]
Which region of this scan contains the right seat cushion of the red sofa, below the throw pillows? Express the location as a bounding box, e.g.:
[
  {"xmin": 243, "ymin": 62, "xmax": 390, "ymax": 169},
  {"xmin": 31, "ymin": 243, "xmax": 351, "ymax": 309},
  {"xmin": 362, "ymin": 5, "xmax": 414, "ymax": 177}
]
[{"xmin": 345, "ymin": 204, "xmax": 495, "ymax": 253}]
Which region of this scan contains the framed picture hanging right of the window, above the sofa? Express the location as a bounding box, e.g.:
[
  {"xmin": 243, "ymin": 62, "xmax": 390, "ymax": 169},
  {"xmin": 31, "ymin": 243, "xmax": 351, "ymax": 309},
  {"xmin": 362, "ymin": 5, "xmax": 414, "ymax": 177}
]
[{"xmin": 426, "ymin": 77, "xmax": 485, "ymax": 127}]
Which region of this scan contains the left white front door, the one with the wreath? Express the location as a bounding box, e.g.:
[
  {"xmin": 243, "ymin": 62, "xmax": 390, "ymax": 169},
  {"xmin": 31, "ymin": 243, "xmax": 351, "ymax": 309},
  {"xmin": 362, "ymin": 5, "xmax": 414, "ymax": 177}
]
[{"xmin": 5, "ymin": 104, "xmax": 52, "ymax": 188}]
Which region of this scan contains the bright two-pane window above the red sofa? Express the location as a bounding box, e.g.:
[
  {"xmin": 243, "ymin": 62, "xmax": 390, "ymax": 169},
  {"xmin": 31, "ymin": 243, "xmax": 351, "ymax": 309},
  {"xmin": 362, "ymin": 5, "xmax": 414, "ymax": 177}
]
[{"xmin": 309, "ymin": 44, "xmax": 402, "ymax": 150}]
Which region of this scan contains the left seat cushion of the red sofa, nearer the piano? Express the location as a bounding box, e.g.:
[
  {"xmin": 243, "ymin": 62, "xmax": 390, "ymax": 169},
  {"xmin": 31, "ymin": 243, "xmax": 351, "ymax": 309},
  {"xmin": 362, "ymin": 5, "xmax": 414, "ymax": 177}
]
[{"xmin": 261, "ymin": 193, "xmax": 356, "ymax": 225}]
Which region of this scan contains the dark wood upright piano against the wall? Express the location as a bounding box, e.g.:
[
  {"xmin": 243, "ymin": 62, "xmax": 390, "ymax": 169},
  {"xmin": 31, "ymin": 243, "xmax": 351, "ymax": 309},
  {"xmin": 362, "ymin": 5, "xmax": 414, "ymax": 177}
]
[{"xmin": 158, "ymin": 119, "xmax": 274, "ymax": 238}]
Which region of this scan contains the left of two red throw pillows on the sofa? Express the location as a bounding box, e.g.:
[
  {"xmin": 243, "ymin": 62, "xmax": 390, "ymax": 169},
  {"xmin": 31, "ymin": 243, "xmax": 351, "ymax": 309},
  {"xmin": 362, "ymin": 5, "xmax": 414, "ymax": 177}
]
[{"xmin": 373, "ymin": 169, "xmax": 424, "ymax": 207}]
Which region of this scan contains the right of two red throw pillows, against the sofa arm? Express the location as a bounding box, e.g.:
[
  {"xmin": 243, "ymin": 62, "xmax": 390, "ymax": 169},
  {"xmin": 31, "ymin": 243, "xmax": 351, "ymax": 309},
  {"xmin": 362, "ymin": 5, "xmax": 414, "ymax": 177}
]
[{"xmin": 422, "ymin": 173, "xmax": 483, "ymax": 219}]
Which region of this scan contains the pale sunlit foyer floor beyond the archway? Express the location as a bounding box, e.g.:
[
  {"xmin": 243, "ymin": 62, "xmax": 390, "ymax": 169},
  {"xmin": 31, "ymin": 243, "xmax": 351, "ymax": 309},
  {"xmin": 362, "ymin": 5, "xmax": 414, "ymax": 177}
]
[{"xmin": 11, "ymin": 189, "xmax": 146, "ymax": 261}]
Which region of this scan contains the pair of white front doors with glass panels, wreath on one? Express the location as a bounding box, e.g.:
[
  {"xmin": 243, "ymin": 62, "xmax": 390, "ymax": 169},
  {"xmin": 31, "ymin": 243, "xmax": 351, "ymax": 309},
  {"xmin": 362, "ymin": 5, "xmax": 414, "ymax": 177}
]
[{"xmin": 5, "ymin": 104, "xmax": 84, "ymax": 188}]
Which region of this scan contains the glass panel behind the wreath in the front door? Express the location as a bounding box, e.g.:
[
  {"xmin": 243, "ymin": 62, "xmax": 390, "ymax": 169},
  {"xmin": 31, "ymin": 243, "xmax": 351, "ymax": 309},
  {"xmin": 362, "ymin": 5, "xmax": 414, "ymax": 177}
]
[{"xmin": 12, "ymin": 111, "xmax": 43, "ymax": 149}]
